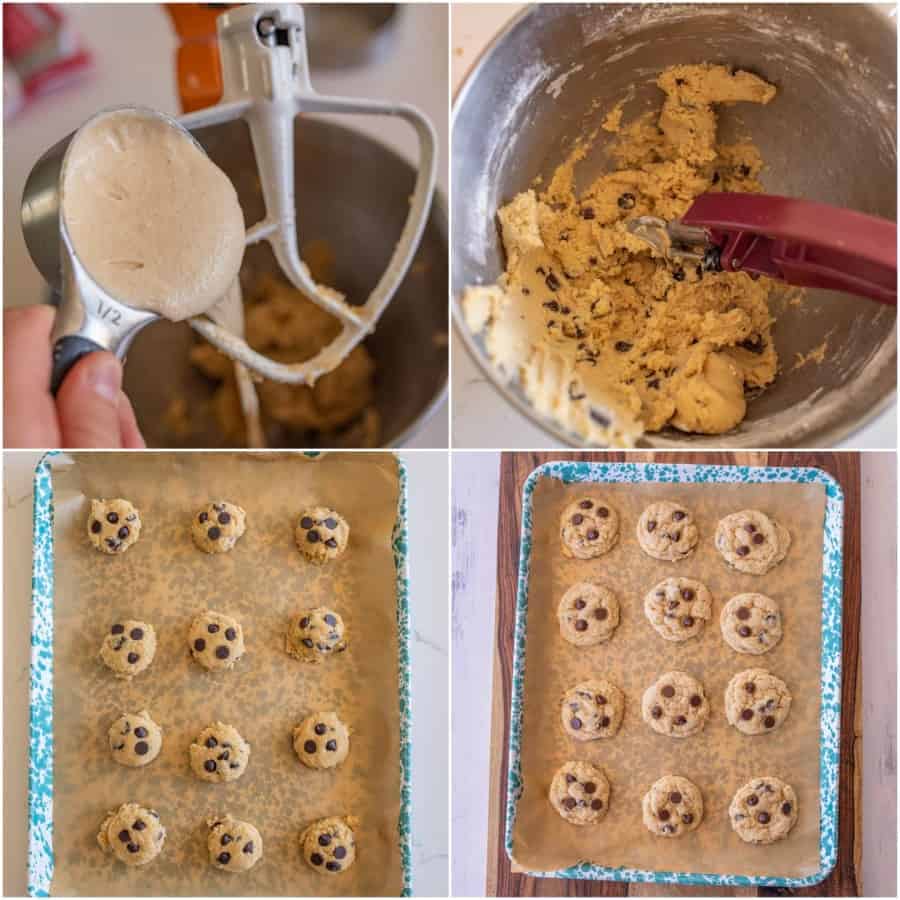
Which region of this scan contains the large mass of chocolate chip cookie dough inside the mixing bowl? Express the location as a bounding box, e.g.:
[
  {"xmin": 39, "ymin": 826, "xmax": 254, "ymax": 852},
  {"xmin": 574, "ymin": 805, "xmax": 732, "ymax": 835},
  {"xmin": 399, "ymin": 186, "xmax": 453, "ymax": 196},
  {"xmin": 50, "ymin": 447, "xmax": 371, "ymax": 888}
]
[{"xmin": 462, "ymin": 63, "xmax": 778, "ymax": 446}]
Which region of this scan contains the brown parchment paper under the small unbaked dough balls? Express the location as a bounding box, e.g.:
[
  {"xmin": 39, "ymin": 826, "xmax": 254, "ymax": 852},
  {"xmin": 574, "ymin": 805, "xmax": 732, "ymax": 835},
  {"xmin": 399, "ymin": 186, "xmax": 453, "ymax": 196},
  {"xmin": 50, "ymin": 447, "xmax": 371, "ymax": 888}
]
[{"xmin": 52, "ymin": 453, "xmax": 402, "ymax": 896}]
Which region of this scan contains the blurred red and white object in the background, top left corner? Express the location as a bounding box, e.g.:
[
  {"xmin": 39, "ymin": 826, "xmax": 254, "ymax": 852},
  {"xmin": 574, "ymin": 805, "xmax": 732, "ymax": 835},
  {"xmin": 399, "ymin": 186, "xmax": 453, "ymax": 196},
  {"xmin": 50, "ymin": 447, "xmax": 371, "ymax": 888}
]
[{"xmin": 3, "ymin": 3, "xmax": 92, "ymax": 110}]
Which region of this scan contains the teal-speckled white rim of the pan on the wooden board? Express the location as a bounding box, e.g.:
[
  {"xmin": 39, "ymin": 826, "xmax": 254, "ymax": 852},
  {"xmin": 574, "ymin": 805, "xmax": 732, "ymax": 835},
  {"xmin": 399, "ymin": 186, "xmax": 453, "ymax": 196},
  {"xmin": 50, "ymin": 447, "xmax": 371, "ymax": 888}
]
[{"xmin": 504, "ymin": 461, "xmax": 844, "ymax": 887}]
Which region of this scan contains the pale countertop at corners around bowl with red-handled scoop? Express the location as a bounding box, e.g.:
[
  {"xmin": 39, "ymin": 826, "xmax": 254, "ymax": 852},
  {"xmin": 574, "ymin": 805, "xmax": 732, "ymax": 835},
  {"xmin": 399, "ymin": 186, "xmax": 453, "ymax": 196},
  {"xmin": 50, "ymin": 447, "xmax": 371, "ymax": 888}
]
[{"xmin": 450, "ymin": 3, "xmax": 897, "ymax": 450}]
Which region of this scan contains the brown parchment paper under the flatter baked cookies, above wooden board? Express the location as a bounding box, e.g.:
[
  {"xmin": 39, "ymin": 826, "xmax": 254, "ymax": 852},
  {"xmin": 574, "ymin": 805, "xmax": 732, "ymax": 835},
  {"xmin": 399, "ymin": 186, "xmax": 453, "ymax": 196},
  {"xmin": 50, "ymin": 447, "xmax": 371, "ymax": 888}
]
[{"xmin": 513, "ymin": 478, "xmax": 825, "ymax": 876}]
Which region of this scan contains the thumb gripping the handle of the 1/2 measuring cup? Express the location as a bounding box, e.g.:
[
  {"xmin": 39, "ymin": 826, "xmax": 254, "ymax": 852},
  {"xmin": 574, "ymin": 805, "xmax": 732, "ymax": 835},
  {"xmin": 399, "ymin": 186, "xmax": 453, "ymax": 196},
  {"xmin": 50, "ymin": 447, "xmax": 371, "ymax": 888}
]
[{"xmin": 56, "ymin": 351, "xmax": 122, "ymax": 448}]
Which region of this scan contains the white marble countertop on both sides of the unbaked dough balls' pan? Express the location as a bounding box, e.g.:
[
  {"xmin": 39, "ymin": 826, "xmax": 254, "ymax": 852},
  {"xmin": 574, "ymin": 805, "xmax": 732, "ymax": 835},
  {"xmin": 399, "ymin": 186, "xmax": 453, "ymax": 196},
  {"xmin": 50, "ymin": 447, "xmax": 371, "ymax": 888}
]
[{"xmin": 3, "ymin": 451, "xmax": 450, "ymax": 897}]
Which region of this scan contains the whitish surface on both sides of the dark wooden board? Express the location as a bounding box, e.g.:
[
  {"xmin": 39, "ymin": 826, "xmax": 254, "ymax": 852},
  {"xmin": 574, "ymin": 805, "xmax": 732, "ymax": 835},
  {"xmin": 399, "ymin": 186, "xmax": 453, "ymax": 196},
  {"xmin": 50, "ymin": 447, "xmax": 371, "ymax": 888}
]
[{"xmin": 451, "ymin": 451, "xmax": 897, "ymax": 897}]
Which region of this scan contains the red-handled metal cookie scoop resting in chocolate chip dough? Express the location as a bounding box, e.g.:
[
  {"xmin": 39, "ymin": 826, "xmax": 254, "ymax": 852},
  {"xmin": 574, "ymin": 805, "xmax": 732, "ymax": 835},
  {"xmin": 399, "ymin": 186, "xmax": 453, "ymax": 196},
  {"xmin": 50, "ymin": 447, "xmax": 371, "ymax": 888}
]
[{"xmin": 626, "ymin": 192, "xmax": 897, "ymax": 306}]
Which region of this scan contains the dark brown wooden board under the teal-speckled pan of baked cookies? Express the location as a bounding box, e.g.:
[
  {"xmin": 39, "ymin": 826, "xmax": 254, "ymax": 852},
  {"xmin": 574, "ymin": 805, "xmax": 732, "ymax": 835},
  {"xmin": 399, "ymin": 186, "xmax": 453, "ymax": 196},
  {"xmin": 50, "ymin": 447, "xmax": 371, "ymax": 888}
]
[{"xmin": 486, "ymin": 452, "xmax": 862, "ymax": 897}]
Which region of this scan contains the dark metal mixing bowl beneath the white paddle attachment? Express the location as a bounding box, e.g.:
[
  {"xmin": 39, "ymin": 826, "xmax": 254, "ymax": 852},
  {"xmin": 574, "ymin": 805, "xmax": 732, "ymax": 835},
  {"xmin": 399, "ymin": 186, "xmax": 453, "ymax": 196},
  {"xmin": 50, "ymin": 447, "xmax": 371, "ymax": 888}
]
[{"xmin": 125, "ymin": 118, "xmax": 449, "ymax": 447}]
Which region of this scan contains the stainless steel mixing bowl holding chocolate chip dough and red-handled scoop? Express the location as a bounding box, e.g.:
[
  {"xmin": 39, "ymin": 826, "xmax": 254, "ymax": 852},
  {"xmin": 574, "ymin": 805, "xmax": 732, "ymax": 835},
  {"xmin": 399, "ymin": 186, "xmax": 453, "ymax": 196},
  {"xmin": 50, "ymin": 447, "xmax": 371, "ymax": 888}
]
[{"xmin": 452, "ymin": 4, "xmax": 897, "ymax": 448}]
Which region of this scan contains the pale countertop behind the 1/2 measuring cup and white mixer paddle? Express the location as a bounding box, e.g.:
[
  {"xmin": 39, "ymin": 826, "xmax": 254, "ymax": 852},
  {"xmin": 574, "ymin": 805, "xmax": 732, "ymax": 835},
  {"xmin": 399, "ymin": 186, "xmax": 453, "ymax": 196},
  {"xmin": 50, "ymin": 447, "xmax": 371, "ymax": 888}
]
[{"xmin": 3, "ymin": 3, "xmax": 449, "ymax": 447}]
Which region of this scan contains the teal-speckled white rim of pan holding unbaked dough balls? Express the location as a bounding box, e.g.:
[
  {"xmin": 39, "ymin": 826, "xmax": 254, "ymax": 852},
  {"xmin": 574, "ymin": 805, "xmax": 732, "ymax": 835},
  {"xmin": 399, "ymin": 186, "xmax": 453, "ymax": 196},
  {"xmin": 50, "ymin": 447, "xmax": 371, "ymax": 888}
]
[{"xmin": 28, "ymin": 450, "xmax": 412, "ymax": 897}]
